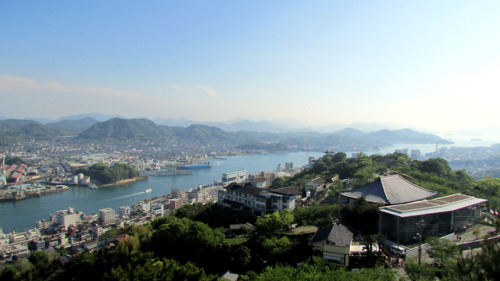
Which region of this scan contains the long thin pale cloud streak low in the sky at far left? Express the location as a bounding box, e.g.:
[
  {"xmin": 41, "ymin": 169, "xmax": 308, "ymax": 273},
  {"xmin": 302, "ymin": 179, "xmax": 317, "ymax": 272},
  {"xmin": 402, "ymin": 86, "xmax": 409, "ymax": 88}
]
[{"xmin": 0, "ymin": 74, "xmax": 140, "ymax": 98}]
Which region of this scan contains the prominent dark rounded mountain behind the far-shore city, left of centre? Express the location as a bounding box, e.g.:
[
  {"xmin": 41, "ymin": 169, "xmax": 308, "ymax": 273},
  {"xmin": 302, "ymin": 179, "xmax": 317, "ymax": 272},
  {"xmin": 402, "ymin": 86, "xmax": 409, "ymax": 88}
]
[{"xmin": 77, "ymin": 118, "xmax": 168, "ymax": 140}]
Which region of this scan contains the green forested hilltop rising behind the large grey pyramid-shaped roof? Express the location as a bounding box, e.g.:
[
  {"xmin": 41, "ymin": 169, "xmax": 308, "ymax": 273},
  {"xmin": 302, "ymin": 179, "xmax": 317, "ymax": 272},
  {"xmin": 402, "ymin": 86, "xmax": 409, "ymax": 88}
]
[{"xmin": 272, "ymin": 152, "xmax": 500, "ymax": 209}]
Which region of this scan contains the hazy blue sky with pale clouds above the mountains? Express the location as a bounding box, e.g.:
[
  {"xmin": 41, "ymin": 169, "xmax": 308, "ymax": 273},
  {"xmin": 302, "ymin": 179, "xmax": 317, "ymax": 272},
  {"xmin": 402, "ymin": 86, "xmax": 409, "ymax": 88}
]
[{"xmin": 0, "ymin": 0, "xmax": 500, "ymax": 132}]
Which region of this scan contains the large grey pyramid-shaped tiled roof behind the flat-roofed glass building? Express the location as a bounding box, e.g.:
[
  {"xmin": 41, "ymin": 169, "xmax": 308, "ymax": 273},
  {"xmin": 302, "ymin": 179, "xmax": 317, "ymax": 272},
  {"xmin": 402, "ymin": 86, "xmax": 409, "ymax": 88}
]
[{"xmin": 340, "ymin": 175, "xmax": 438, "ymax": 205}]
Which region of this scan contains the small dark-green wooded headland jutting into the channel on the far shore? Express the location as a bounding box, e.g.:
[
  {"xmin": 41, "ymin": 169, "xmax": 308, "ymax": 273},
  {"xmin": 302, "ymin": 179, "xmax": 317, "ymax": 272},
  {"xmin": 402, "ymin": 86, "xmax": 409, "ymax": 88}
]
[{"xmin": 75, "ymin": 163, "xmax": 139, "ymax": 184}]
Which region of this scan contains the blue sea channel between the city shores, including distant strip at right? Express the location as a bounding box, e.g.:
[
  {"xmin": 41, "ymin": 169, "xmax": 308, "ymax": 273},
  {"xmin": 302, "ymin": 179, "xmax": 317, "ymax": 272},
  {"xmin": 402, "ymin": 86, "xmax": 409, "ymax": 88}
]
[{"xmin": 0, "ymin": 138, "xmax": 498, "ymax": 233}]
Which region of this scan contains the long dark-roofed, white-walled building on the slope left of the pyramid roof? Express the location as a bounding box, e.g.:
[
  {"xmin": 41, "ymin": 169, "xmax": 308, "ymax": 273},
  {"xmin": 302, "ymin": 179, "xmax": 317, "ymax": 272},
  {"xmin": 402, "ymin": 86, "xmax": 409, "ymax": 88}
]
[{"xmin": 218, "ymin": 183, "xmax": 300, "ymax": 215}]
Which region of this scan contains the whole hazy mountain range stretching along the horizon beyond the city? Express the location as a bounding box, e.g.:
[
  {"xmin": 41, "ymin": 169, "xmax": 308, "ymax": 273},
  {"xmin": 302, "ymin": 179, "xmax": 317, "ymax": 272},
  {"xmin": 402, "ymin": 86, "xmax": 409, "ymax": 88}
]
[{"xmin": 0, "ymin": 117, "xmax": 451, "ymax": 151}]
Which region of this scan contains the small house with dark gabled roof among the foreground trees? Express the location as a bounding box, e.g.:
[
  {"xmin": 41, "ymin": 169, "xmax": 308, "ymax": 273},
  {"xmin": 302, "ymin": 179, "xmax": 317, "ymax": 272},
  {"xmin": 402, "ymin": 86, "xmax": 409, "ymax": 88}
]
[{"xmin": 309, "ymin": 222, "xmax": 360, "ymax": 267}]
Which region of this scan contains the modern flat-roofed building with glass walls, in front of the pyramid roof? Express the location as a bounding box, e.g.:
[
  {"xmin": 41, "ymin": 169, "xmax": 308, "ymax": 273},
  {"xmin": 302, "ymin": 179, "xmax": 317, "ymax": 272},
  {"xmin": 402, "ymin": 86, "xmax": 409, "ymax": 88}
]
[{"xmin": 378, "ymin": 194, "xmax": 488, "ymax": 244}]
